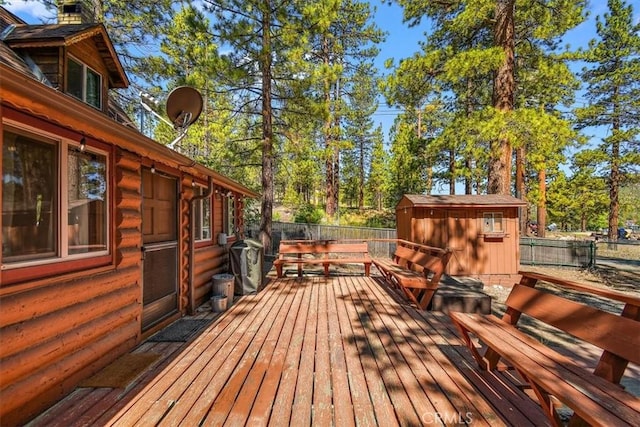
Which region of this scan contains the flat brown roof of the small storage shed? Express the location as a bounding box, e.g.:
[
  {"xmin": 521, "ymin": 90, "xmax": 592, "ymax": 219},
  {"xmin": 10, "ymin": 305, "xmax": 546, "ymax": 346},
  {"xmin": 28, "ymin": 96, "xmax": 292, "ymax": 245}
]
[{"xmin": 398, "ymin": 194, "xmax": 526, "ymax": 208}]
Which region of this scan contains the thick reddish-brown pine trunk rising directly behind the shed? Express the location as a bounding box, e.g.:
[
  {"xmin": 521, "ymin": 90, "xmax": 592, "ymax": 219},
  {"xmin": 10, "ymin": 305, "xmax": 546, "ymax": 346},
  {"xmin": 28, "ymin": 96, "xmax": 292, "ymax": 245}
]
[{"xmin": 487, "ymin": 0, "xmax": 515, "ymax": 194}]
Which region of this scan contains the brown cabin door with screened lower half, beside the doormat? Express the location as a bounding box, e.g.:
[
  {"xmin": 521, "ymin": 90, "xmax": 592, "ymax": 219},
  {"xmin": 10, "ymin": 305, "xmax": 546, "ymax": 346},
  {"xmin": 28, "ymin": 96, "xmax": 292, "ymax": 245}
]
[{"xmin": 142, "ymin": 169, "xmax": 178, "ymax": 330}]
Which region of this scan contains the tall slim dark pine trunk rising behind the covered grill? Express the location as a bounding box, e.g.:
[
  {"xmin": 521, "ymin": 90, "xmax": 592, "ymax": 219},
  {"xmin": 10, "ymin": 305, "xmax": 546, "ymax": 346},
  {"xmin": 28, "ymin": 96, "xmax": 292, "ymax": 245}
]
[{"xmin": 260, "ymin": 0, "xmax": 274, "ymax": 249}]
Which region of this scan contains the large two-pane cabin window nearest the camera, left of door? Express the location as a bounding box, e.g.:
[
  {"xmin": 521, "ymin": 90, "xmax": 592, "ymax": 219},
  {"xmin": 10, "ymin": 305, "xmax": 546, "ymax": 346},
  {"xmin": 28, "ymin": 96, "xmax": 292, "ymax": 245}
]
[{"xmin": 2, "ymin": 128, "xmax": 108, "ymax": 267}]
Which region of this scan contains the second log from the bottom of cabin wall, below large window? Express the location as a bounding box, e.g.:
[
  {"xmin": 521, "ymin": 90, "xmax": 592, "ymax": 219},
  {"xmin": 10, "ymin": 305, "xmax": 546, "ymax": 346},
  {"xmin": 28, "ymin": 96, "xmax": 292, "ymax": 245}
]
[{"xmin": 0, "ymin": 304, "xmax": 140, "ymax": 388}]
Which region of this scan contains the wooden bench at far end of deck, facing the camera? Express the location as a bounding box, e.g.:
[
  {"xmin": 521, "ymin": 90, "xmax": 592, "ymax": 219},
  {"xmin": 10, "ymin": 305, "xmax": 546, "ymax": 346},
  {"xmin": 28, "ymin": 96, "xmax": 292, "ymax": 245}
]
[{"xmin": 273, "ymin": 240, "xmax": 371, "ymax": 277}]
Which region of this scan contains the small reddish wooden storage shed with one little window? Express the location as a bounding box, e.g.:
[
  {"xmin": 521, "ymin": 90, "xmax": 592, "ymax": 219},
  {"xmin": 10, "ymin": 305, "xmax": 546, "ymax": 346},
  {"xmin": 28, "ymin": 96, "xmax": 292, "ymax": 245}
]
[{"xmin": 396, "ymin": 194, "xmax": 526, "ymax": 284}]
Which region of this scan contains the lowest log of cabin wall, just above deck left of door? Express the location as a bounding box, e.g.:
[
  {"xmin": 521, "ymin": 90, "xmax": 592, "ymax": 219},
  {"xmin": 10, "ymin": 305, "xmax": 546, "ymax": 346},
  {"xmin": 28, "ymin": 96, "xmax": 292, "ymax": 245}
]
[{"xmin": 0, "ymin": 323, "xmax": 139, "ymax": 425}]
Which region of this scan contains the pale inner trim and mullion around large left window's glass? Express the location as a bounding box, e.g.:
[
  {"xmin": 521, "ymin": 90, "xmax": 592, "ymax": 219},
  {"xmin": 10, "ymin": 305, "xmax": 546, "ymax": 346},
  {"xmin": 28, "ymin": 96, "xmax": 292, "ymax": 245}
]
[{"xmin": 1, "ymin": 120, "xmax": 112, "ymax": 270}]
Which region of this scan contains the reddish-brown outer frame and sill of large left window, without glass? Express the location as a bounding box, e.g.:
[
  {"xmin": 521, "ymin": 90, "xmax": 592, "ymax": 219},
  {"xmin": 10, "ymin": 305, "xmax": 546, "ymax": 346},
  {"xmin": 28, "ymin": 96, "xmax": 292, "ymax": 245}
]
[{"xmin": 0, "ymin": 120, "xmax": 114, "ymax": 283}]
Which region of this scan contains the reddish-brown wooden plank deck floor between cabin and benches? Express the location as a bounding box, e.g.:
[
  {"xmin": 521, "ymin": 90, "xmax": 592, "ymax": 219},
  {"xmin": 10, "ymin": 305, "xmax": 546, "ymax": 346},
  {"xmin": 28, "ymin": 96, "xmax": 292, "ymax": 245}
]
[{"xmin": 32, "ymin": 276, "xmax": 548, "ymax": 426}]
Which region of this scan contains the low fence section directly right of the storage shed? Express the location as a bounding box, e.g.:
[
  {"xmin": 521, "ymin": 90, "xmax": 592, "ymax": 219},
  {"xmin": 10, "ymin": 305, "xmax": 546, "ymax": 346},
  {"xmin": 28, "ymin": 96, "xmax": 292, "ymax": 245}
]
[{"xmin": 520, "ymin": 237, "xmax": 596, "ymax": 267}]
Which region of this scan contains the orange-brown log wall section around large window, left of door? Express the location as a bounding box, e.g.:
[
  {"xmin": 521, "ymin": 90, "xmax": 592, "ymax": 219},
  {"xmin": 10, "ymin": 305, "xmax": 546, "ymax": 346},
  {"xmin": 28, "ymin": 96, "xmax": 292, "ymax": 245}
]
[{"xmin": 0, "ymin": 150, "xmax": 142, "ymax": 425}]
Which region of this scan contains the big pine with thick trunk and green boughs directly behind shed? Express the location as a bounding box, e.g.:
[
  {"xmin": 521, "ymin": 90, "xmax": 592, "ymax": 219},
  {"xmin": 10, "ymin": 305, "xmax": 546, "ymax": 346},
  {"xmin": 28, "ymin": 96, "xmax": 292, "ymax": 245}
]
[{"xmin": 390, "ymin": 0, "xmax": 585, "ymax": 194}]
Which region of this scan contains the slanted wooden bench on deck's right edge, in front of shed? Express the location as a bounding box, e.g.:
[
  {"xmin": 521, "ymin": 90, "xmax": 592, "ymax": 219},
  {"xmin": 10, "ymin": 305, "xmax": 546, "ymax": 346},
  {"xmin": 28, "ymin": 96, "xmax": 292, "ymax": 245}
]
[{"xmin": 373, "ymin": 240, "xmax": 452, "ymax": 310}]
